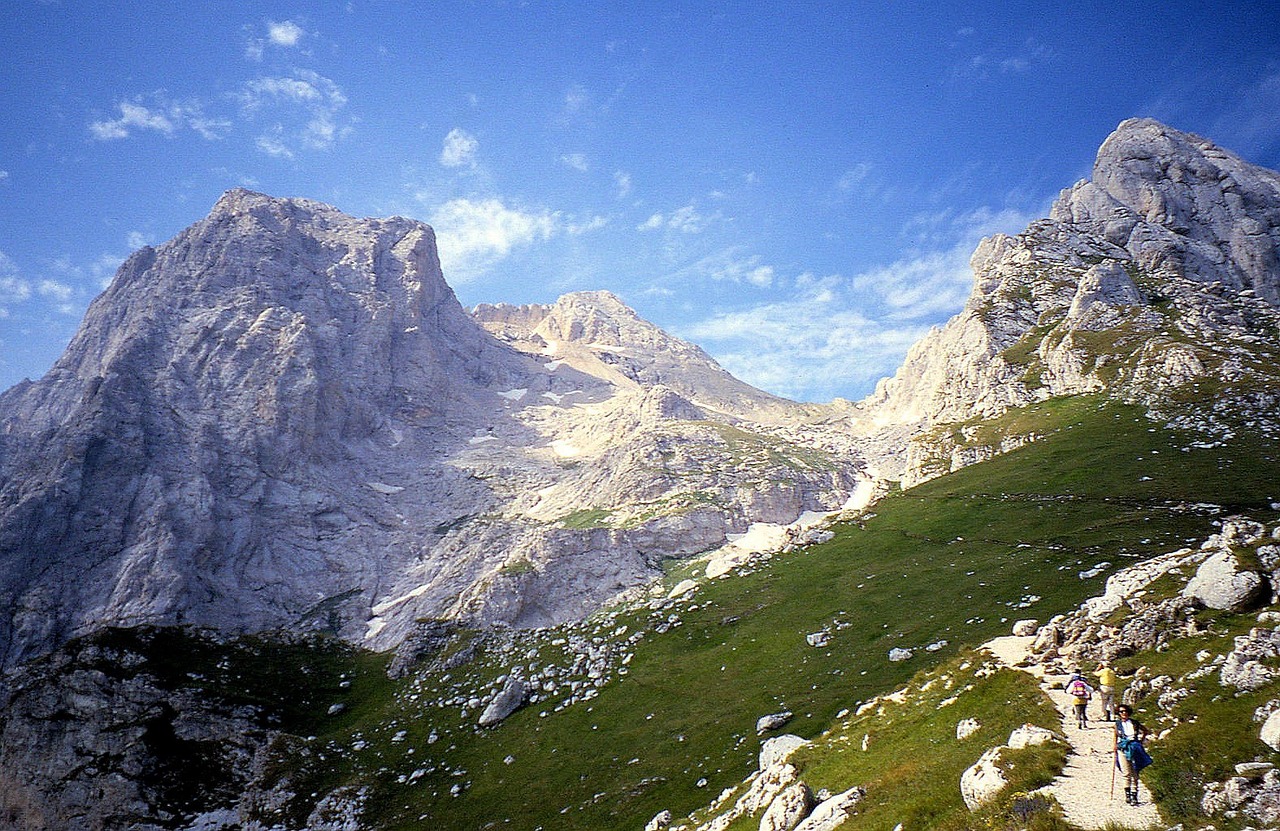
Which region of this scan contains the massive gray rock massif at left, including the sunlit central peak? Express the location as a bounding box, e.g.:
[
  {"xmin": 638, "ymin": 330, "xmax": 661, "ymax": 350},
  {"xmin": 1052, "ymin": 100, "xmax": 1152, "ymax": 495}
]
[{"xmin": 0, "ymin": 191, "xmax": 860, "ymax": 665}]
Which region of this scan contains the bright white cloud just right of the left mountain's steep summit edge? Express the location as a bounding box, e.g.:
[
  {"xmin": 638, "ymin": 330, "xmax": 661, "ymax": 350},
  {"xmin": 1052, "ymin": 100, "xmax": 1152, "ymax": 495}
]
[{"xmin": 429, "ymin": 198, "xmax": 605, "ymax": 283}]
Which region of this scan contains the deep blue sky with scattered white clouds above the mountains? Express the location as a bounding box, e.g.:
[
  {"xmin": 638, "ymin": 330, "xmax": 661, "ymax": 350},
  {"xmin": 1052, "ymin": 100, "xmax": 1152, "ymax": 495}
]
[{"xmin": 0, "ymin": 0, "xmax": 1280, "ymax": 401}]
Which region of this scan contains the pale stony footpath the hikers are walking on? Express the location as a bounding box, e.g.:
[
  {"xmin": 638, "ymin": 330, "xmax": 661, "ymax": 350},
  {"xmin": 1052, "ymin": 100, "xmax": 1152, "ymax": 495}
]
[{"xmin": 984, "ymin": 636, "xmax": 1164, "ymax": 828}]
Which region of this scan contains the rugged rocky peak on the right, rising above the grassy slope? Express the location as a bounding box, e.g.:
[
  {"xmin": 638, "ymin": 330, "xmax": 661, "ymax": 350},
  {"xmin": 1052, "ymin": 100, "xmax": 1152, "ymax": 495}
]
[{"xmin": 855, "ymin": 119, "xmax": 1280, "ymax": 480}]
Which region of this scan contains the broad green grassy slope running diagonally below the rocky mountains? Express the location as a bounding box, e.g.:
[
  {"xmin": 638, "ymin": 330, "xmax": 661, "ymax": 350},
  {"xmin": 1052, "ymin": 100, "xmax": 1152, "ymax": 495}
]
[{"xmin": 329, "ymin": 398, "xmax": 1277, "ymax": 828}]
